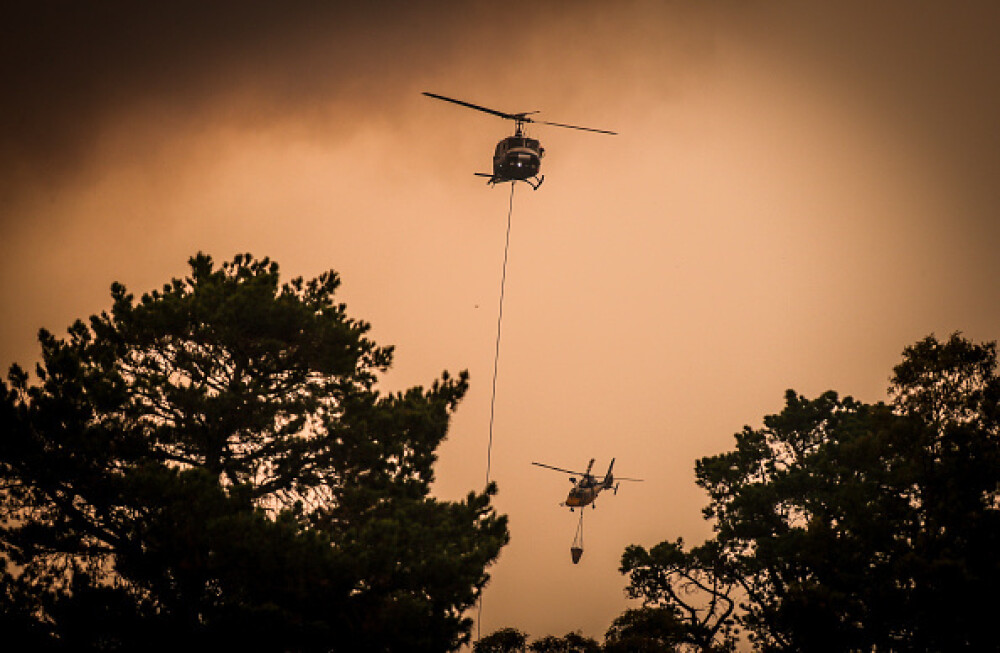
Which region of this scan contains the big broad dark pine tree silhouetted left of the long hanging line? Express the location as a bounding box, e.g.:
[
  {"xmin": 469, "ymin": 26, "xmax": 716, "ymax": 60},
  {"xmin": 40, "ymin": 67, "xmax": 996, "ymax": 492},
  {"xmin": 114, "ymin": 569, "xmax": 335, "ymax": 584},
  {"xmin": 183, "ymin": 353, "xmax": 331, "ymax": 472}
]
[{"xmin": 0, "ymin": 254, "xmax": 508, "ymax": 651}]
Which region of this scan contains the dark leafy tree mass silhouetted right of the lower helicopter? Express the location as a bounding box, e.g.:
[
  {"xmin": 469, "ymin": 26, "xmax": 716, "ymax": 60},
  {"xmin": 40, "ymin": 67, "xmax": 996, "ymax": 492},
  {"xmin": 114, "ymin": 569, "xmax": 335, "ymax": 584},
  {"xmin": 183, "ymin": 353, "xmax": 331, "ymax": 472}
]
[{"xmin": 622, "ymin": 334, "xmax": 1000, "ymax": 650}]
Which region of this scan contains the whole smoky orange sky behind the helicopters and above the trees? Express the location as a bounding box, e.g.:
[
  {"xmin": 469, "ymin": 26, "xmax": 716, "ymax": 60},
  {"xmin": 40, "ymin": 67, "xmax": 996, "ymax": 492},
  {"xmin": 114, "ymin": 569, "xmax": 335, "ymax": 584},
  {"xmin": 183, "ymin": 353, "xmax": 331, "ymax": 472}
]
[{"xmin": 0, "ymin": 1, "xmax": 1000, "ymax": 638}]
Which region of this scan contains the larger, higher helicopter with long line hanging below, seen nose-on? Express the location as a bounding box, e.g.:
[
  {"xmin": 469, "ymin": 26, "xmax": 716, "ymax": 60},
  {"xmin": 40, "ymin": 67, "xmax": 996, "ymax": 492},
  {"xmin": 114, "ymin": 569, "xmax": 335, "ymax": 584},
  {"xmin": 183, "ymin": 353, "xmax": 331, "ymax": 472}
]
[{"xmin": 424, "ymin": 91, "xmax": 617, "ymax": 190}]
